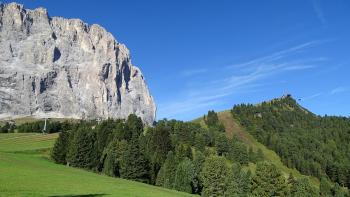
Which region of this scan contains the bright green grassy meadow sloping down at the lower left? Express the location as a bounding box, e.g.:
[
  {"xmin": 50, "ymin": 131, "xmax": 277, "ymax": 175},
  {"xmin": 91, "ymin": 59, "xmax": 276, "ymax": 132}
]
[{"xmin": 0, "ymin": 134, "xmax": 191, "ymax": 197}]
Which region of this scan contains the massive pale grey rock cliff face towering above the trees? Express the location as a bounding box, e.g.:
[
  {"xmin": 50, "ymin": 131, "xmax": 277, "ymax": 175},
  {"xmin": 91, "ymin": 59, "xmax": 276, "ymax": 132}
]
[{"xmin": 0, "ymin": 3, "xmax": 156, "ymax": 123}]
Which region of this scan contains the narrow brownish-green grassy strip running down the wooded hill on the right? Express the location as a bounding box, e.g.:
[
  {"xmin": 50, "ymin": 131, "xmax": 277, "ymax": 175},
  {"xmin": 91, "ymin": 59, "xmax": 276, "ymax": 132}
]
[{"xmin": 194, "ymin": 110, "xmax": 319, "ymax": 187}]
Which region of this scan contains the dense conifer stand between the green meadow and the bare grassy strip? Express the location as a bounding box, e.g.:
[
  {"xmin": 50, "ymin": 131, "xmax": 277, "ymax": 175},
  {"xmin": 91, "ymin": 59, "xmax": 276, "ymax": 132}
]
[{"xmin": 52, "ymin": 111, "xmax": 348, "ymax": 196}]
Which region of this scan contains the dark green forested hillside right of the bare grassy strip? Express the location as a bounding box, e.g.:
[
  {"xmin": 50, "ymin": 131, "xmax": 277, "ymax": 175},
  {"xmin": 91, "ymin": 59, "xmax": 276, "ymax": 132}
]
[{"xmin": 231, "ymin": 95, "xmax": 350, "ymax": 187}]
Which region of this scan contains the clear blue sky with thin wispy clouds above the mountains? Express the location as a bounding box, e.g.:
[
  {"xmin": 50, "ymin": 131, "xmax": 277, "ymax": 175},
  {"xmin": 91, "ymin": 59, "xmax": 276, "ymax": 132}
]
[{"xmin": 7, "ymin": 0, "xmax": 350, "ymax": 120}]
